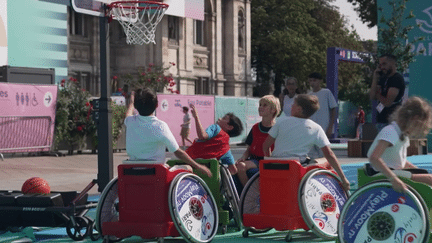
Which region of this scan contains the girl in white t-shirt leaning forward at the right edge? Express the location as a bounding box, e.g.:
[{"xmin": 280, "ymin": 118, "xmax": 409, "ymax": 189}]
[{"xmin": 367, "ymin": 97, "xmax": 432, "ymax": 192}]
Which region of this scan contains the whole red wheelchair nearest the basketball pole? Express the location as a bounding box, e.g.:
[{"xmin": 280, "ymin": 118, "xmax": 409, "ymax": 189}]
[{"xmin": 96, "ymin": 161, "xmax": 219, "ymax": 243}]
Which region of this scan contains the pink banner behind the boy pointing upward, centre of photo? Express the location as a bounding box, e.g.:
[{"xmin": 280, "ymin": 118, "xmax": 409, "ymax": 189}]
[{"xmin": 156, "ymin": 94, "xmax": 215, "ymax": 146}]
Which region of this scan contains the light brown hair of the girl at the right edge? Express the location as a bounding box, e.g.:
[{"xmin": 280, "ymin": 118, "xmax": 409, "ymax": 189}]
[{"xmin": 390, "ymin": 96, "xmax": 432, "ymax": 139}]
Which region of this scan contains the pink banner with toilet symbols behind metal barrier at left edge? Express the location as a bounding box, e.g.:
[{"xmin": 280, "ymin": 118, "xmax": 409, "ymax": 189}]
[{"xmin": 0, "ymin": 83, "xmax": 57, "ymax": 153}]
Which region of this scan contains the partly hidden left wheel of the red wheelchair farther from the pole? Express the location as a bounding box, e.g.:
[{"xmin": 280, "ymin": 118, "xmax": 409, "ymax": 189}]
[{"xmin": 240, "ymin": 172, "xmax": 271, "ymax": 234}]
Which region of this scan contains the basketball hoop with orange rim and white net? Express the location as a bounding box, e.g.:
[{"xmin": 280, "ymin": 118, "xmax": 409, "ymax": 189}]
[{"xmin": 108, "ymin": 1, "xmax": 168, "ymax": 45}]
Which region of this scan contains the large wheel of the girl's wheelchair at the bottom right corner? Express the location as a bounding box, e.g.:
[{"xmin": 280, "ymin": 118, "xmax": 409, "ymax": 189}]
[{"xmin": 338, "ymin": 180, "xmax": 430, "ymax": 243}]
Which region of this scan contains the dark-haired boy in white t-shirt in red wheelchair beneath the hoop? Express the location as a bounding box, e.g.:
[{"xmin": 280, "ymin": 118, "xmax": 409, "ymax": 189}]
[{"xmin": 125, "ymin": 88, "xmax": 211, "ymax": 177}]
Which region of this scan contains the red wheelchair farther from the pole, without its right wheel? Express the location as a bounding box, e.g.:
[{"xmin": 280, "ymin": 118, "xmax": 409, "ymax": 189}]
[{"xmin": 240, "ymin": 160, "xmax": 348, "ymax": 241}]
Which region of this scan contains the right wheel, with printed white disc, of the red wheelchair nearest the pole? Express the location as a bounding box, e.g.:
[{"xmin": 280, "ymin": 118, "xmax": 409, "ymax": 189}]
[{"xmin": 168, "ymin": 173, "xmax": 219, "ymax": 243}]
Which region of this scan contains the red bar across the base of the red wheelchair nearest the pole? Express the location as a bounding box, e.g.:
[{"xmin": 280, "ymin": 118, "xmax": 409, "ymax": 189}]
[{"xmin": 102, "ymin": 222, "xmax": 180, "ymax": 239}]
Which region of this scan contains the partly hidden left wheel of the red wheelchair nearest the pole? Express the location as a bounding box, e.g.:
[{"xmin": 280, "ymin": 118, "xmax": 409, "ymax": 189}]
[{"xmin": 95, "ymin": 177, "xmax": 121, "ymax": 242}]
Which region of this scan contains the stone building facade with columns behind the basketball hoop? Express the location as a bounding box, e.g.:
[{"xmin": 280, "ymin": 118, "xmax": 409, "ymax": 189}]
[{"xmin": 68, "ymin": 0, "xmax": 254, "ymax": 96}]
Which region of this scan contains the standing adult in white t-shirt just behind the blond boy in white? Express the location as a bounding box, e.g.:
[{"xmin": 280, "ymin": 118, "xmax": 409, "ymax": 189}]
[{"xmin": 308, "ymin": 73, "xmax": 337, "ymax": 158}]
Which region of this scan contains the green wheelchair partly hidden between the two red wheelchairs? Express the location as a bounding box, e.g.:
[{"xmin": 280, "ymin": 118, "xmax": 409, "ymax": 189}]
[{"xmin": 167, "ymin": 159, "xmax": 242, "ymax": 234}]
